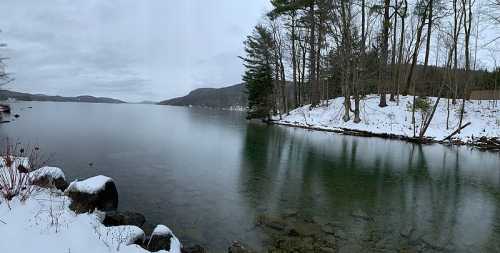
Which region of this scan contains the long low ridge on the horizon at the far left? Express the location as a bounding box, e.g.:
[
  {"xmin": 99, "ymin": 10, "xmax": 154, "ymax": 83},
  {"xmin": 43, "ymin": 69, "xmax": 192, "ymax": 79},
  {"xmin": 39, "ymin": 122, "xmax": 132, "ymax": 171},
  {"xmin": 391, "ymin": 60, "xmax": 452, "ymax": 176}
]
[{"xmin": 0, "ymin": 90, "xmax": 126, "ymax": 104}]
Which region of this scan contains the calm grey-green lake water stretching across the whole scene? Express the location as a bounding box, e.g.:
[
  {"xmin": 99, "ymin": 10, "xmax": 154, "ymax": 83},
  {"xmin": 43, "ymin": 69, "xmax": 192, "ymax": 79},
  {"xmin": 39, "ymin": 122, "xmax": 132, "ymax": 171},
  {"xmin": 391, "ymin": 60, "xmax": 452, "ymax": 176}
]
[{"xmin": 0, "ymin": 102, "xmax": 500, "ymax": 252}]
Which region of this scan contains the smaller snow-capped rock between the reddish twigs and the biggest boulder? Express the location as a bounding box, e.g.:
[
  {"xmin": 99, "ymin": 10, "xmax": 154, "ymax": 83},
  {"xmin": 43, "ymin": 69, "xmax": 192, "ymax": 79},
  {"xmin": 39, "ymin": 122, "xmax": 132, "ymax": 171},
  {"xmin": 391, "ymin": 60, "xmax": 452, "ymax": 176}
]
[{"xmin": 30, "ymin": 167, "xmax": 68, "ymax": 191}]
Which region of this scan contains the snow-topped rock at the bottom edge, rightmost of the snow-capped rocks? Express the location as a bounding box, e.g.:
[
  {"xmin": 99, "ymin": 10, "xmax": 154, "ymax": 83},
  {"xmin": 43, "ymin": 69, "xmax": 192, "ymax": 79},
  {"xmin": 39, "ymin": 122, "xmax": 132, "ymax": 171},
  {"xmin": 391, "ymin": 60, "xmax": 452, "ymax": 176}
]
[{"xmin": 143, "ymin": 225, "xmax": 181, "ymax": 253}]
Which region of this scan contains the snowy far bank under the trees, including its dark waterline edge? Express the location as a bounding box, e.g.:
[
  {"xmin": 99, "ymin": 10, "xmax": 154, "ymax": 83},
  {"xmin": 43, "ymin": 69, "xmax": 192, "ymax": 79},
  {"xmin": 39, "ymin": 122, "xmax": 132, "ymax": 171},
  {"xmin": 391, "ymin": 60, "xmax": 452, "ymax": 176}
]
[{"xmin": 266, "ymin": 95, "xmax": 500, "ymax": 151}]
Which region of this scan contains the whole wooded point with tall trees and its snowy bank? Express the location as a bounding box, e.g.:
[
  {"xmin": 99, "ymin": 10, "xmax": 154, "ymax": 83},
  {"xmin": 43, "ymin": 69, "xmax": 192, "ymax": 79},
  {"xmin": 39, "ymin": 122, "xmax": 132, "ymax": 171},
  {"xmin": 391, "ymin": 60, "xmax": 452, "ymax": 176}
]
[{"xmin": 240, "ymin": 0, "xmax": 500, "ymax": 155}]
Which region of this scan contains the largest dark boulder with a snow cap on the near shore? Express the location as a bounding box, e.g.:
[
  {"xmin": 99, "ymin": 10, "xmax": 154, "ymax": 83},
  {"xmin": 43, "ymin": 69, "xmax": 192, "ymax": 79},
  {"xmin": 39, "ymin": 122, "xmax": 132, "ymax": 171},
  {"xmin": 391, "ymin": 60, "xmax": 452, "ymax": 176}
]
[{"xmin": 64, "ymin": 176, "xmax": 118, "ymax": 213}]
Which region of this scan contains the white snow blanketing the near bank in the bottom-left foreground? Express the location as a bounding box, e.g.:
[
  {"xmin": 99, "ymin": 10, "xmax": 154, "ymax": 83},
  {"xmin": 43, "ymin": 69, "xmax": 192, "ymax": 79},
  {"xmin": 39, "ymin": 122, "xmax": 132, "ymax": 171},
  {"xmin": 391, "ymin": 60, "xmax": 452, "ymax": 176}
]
[{"xmin": 0, "ymin": 165, "xmax": 181, "ymax": 253}]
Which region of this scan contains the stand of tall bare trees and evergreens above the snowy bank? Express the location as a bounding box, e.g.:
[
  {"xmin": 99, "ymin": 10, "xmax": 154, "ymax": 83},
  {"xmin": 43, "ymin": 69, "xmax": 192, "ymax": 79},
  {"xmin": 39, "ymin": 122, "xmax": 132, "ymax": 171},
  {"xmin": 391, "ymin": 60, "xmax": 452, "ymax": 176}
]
[{"xmin": 242, "ymin": 0, "xmax": 500, "ymax": 131}]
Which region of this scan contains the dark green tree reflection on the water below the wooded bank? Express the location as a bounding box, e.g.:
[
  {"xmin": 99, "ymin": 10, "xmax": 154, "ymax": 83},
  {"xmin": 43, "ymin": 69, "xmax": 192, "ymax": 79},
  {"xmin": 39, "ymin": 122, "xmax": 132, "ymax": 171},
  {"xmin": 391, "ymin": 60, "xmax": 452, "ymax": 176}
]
[{"xmin": 240, "ymin": 126, "xmax": 499, "ymax": 250}]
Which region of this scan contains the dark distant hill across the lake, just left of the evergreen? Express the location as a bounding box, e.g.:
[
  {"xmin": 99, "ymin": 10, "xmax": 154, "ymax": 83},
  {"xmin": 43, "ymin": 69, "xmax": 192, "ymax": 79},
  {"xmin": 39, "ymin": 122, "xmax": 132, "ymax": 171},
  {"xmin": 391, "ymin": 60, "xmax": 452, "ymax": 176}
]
[{"xmin": 159, "ymin": 83, "xmax": 248, "ymax": 109}]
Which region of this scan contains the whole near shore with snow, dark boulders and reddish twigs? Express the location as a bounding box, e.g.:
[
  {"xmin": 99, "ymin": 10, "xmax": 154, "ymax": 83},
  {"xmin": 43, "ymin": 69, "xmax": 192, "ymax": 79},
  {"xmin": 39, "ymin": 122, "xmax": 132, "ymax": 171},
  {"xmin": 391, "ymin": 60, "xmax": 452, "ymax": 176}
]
[{"xmin": 0, "ymin": 140, "xmax": 254, "ymax": 253}]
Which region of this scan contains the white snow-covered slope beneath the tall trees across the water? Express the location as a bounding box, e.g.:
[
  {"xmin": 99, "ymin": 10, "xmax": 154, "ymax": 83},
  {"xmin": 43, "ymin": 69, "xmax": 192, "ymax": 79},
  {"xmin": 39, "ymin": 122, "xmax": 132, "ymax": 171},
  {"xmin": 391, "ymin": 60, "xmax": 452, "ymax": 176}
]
[{"xmin": 274, "ymin": 95, "xmax": 500, "ymax": 142}]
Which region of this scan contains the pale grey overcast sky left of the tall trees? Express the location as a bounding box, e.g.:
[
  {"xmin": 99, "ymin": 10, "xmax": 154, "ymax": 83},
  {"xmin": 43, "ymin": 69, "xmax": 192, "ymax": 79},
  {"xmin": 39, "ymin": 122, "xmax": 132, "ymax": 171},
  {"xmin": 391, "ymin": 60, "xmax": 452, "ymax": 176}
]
[{"xmin": 0, "ymin": 0, "xmax": 270, "ymax": 101}]
